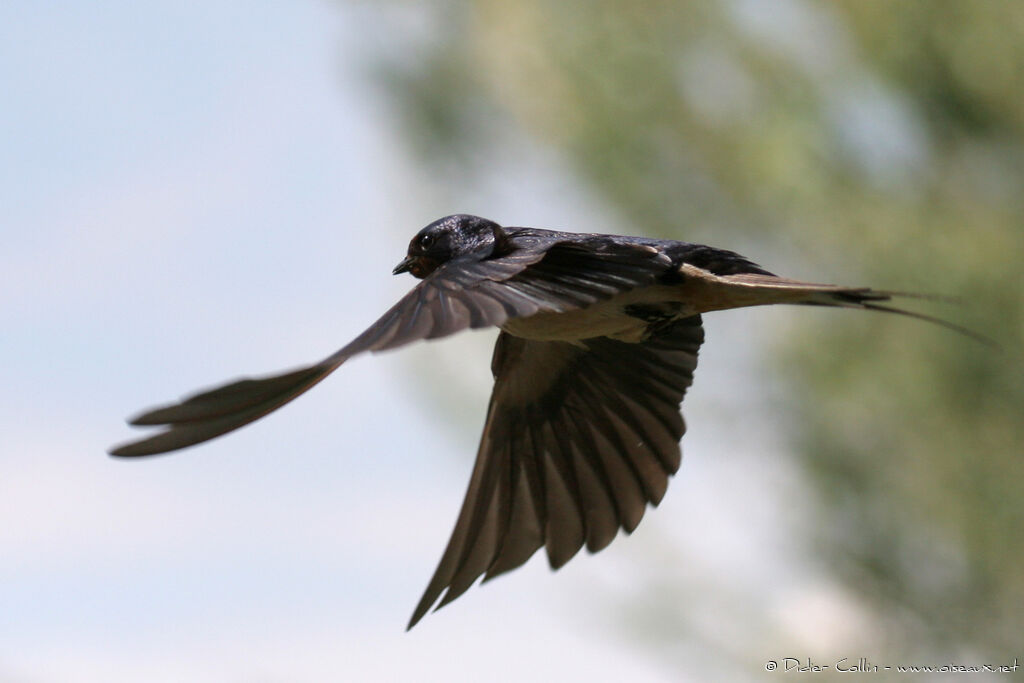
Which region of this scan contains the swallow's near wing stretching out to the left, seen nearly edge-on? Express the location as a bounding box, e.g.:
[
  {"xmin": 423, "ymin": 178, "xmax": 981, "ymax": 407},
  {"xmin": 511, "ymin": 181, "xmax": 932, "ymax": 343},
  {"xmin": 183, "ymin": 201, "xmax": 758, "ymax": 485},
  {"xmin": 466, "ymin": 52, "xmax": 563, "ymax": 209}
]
[{"xmin": 111, "ymin": 240, "xmax": 669, "ymax": 457}]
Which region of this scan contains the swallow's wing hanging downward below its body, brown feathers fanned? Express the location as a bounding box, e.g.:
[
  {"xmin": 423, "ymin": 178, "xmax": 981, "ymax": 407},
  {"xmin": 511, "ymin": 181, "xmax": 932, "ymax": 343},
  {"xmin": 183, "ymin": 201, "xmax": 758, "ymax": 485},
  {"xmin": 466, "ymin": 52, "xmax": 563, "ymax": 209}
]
[{"xmin": 409, "ymin": 315, "xmax": 703, "ymax": 628}]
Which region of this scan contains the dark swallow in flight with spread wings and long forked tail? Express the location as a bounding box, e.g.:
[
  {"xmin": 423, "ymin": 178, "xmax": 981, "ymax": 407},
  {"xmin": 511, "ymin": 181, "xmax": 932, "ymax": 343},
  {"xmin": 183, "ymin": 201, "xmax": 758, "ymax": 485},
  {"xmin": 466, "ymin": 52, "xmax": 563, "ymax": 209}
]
[{"xmin": 111, "ymin": 214, "xmax": 977, "ymax": 629}]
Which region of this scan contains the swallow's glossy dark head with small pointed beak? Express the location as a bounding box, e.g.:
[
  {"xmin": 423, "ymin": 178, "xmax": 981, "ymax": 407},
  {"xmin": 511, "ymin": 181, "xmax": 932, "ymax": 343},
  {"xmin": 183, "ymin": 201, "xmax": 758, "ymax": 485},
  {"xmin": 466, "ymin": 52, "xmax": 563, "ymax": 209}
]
[{"xmin": 393, "ymin": 213, "xmax": 507, "ymax": 279}]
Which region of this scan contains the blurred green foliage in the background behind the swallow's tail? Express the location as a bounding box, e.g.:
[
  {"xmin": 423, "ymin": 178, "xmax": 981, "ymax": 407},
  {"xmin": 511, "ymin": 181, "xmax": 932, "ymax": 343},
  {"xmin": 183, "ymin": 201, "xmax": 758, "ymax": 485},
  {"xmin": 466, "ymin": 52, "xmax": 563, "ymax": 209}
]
[{"xmin": 364, "ymin": 0, "xmax": 1024, "ymax": 660}]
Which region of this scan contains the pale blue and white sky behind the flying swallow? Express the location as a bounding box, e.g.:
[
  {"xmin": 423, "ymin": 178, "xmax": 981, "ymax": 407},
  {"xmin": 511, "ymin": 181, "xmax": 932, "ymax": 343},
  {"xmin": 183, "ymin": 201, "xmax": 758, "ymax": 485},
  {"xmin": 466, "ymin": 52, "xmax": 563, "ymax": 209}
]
[{"xmin": 0, "ymin": 1, "xmax": 858, "ymax": 683}]
